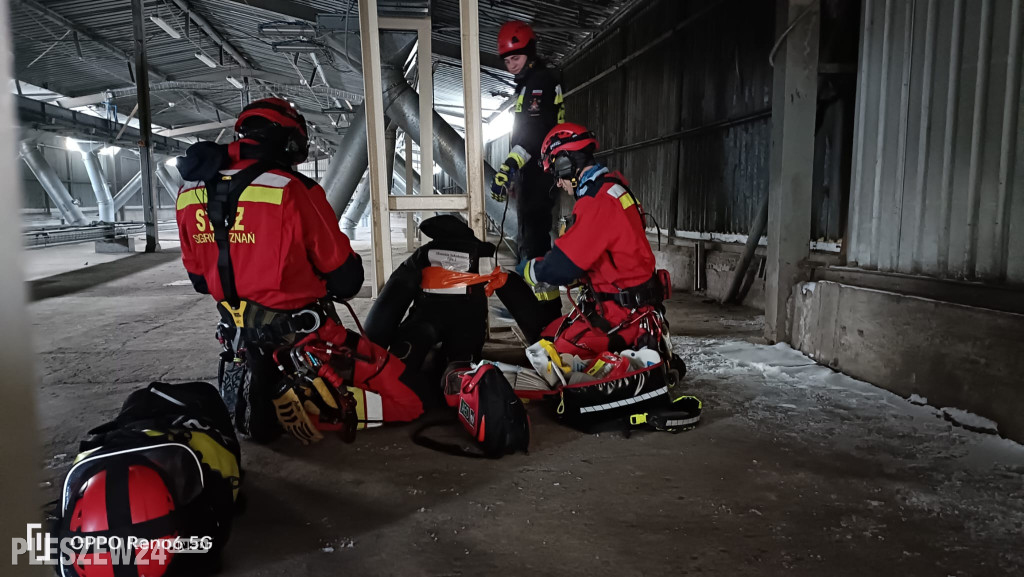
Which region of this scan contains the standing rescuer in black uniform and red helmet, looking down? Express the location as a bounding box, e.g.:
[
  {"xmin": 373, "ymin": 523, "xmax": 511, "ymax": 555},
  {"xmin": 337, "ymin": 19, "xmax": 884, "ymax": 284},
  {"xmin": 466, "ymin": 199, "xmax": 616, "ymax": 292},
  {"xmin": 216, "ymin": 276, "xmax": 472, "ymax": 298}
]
[{"xmin": 490, "ymin": 20, "xmax": 565, "ymax": 318}]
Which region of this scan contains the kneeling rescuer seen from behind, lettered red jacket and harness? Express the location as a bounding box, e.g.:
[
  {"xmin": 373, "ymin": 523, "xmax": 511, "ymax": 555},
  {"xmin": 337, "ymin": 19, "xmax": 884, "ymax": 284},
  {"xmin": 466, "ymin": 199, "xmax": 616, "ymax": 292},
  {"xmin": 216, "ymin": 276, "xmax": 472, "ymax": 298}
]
[{"xmin": 177, "ymin": 98, "xmax": 422, "ymax": 442}]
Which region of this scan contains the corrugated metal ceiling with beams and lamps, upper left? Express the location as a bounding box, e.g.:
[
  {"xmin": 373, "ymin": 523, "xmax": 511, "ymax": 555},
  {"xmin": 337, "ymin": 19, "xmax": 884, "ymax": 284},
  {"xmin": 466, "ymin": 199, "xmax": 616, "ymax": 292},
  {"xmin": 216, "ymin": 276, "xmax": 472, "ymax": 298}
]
[{"xmin": 11, "ymin": 0, "xmax": 628, "ymax": 148}]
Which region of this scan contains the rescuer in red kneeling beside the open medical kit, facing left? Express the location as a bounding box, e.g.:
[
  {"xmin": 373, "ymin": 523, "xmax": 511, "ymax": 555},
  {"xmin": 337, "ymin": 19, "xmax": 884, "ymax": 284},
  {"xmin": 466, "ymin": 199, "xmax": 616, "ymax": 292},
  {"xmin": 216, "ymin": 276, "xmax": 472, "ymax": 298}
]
[{"xmin": 517, "ymin": 123, "xmax": 665, "ymax": 359}]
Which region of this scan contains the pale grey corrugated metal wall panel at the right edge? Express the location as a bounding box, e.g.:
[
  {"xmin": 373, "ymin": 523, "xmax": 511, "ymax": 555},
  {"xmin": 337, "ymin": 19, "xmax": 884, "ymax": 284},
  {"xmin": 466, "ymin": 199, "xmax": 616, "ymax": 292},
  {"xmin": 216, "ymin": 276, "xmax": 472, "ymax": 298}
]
[{"xmin": 848, "ymin": 0, "xmax": 1024, "ymax": 283}]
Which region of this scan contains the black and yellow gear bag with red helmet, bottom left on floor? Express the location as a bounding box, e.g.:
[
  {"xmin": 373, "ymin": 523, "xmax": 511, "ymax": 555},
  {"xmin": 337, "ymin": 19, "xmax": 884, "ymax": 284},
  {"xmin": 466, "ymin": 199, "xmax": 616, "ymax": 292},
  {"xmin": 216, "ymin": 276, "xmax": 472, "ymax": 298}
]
[{"xmin": 52, "ymin": 382, "xmax": 242, "ymax": 577}]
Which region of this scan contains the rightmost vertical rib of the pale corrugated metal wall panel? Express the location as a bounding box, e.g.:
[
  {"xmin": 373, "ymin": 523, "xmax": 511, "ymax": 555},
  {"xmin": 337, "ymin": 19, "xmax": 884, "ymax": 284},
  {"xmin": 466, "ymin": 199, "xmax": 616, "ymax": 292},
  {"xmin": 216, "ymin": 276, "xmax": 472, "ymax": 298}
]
[{"xmin": 992, "ymin": 0, "xmax": 1021, "ymax": 280}]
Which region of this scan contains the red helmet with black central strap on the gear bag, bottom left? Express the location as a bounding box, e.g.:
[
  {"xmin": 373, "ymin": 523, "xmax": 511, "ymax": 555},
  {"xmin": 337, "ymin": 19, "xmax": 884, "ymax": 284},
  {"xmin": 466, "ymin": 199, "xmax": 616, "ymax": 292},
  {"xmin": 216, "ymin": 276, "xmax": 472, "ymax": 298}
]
[{"xmin": 67, "ymin": 464, "xmax": 177, "ymax": 577}]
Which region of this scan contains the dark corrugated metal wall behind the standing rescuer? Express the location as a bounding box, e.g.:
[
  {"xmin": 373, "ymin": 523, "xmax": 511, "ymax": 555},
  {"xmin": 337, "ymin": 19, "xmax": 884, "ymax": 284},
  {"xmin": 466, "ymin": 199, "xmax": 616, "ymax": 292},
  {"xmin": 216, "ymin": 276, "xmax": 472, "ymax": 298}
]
[{"xmin": 563, "ymin": 0, "xmax": 775, "ymax": 234}]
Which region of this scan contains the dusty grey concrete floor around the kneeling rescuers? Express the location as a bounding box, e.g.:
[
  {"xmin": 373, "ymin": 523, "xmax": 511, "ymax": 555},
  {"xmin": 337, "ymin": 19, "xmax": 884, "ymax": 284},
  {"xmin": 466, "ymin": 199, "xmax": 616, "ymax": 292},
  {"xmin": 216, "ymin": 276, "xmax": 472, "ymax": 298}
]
[{"xmin": 24, "ymin": 241, "xmax": 1024, "ymax": 576}]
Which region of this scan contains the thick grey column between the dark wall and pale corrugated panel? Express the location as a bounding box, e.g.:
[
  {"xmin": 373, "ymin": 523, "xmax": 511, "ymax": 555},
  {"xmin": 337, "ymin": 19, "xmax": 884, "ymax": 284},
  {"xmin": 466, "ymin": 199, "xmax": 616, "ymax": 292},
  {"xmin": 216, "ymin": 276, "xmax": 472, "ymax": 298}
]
[{"xmin": 765, "ymin": 0, "xmax": 820, "ymax": 342}]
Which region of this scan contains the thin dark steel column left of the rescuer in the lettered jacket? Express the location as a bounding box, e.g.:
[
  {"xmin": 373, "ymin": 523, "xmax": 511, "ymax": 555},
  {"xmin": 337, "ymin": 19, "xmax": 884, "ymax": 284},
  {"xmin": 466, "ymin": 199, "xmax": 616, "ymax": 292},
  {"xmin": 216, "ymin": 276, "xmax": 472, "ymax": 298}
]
[{"xmin": 131, "ymin": 0, "xmax": 160, "ymax": 252}]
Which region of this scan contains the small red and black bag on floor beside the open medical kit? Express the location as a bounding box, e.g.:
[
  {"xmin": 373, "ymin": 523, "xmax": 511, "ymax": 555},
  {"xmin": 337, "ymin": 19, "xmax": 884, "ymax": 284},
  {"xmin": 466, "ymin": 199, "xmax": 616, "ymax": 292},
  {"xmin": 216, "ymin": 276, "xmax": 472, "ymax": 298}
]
[{"xmin": 413, "ymin": 363, "xmax": 529, "ymax": 458}]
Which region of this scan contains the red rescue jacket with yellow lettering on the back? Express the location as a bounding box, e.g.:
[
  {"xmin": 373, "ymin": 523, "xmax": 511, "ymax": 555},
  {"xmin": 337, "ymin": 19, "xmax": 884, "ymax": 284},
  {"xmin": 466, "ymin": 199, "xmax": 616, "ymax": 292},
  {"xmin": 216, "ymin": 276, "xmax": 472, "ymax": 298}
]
[{"xmin": 177, "ymin": 140, "xmax": 364, "ymax": 311}]
